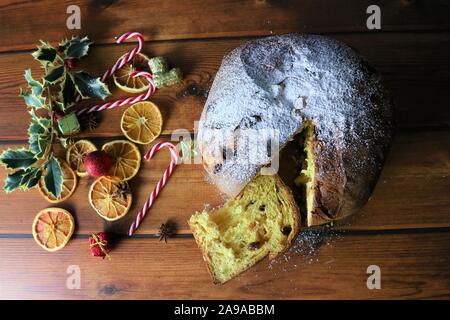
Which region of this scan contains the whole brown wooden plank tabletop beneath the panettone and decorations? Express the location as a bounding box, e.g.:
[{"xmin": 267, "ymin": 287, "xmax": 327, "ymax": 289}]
[{"xmin": 0, "ymin": 0, "xmax": 450, "ymax": 299}]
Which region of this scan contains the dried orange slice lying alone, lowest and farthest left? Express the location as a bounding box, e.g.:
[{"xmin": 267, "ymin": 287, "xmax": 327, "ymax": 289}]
[{"xmin": 33, "ymin": 208, "xmax": 75, "ymax": 252}]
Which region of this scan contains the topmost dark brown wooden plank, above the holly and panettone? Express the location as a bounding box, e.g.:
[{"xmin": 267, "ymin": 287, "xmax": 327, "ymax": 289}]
[{"xmin": 0, "ymin": 0, "xmax": 450, "ymax": 51}]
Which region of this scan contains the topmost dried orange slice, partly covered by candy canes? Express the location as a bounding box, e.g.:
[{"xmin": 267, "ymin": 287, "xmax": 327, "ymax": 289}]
[{"xmin": 113, "ymin": 53, "xmax": 151, "ymax": 93}]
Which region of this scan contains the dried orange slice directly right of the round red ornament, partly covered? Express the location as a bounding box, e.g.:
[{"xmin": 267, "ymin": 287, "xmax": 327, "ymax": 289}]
[{"xmin": 102, "ymin": 140, "xmax": 141, "ymax": 181}]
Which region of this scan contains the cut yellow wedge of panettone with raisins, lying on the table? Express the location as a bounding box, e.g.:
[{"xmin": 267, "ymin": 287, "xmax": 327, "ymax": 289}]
[{"xmin": 189, "ymin": 175, "xmax": 300, "ymax": 283}]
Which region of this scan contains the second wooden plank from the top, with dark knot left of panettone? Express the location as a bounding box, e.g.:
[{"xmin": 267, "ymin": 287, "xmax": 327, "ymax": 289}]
[{"xmin": 0, "ymin": 34, "xmax": 450, "ymax": 140}]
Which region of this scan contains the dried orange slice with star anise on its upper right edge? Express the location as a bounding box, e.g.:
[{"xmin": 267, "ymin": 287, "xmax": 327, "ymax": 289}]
[{"xmin": 89, "ymin": 177, "xmax": 132, "ymax": 221}]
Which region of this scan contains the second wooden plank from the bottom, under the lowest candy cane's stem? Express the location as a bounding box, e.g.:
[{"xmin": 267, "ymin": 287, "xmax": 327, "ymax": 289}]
[{"xmin": 0, "ymin": 130, "xmax": 450, "ymax": 234}]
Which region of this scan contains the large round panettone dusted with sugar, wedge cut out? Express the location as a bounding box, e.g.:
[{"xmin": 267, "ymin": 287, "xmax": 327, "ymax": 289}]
[{"xmin": 191, "ymin": 34, "xmax": 393, "ymax": 282}]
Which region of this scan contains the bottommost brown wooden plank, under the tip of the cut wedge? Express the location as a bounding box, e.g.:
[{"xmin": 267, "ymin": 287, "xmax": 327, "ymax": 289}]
[{"xmin": 0, "ymin": 229, "xmax": 450, "ymax": 299}]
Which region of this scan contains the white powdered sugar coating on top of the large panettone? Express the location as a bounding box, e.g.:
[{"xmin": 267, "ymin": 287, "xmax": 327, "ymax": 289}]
[{"xmin": 198, "ymin": 34, "xmax": 391, "ymax": 210}]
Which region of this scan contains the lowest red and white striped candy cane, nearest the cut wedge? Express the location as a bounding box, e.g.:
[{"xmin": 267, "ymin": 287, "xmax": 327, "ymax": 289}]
[{"xmin": 128, "ymin": 141, "xmax": 180, "ymax": 237}]
